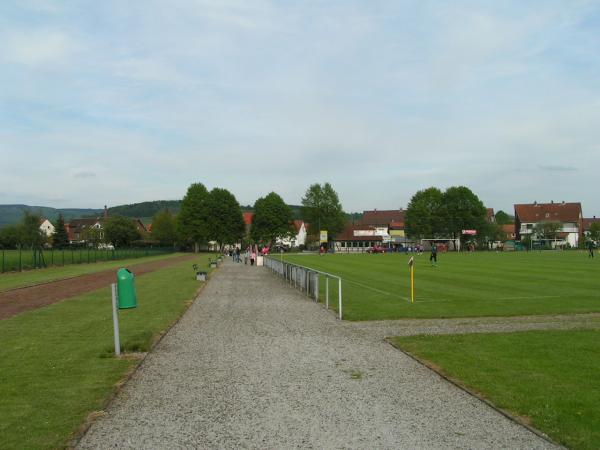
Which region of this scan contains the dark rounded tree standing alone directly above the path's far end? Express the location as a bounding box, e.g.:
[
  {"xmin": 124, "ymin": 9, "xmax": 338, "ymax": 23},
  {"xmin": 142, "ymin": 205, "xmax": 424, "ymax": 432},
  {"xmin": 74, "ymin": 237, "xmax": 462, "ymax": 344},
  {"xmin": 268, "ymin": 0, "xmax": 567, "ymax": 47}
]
[{"xmin": 251, "ymin": 192, "xmax": 292, "ymax": 243}]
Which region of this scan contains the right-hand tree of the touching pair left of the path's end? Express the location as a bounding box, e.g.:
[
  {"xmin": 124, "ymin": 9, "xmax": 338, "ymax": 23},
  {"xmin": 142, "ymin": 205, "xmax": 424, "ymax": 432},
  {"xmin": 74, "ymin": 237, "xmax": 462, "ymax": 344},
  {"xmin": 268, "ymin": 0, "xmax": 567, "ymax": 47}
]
[{"xmin": 206, "ymin": 188, "xmax": 245, "ymax": 250}]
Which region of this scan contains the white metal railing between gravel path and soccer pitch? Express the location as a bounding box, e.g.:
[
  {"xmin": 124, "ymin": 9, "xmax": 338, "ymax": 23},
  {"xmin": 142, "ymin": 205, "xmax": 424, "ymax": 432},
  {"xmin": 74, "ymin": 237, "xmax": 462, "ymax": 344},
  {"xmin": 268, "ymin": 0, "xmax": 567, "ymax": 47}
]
[{"xmin": 264, "ymin": 256, "xmax": 342, "ymax": 320}]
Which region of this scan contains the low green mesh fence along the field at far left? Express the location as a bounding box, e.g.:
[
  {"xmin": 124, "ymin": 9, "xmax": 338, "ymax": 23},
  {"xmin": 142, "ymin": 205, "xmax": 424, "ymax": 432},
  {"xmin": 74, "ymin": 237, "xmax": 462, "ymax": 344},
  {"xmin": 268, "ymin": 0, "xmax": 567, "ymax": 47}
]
[{"xmin": 0, "ymin": 244, "xmax": 172, "ymax": 273}]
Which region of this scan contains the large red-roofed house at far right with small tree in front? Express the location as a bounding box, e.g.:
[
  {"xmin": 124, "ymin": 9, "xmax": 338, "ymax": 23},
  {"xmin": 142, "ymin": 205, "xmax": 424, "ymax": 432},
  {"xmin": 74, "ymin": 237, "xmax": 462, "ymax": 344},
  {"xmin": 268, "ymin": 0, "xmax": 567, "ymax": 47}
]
[{"xmin": 515, "ymin": 202, "xmax": 583, "ymax": 247}]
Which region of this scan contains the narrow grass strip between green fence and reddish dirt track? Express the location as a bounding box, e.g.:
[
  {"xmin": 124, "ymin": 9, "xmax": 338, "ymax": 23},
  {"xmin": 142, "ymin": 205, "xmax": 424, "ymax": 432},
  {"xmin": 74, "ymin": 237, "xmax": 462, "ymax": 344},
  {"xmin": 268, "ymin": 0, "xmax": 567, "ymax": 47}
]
[{"xmin": 0, "ymin": 253, "xmax": 188, "ymax": 292}]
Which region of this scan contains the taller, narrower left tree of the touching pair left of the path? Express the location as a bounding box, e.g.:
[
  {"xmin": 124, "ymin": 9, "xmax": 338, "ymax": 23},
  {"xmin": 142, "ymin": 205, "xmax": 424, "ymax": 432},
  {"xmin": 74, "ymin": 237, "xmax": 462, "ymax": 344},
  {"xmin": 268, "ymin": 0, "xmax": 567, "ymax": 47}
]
[{"xmin": 177, "ymin": 183, "xmax": 208, "ymax": 253}]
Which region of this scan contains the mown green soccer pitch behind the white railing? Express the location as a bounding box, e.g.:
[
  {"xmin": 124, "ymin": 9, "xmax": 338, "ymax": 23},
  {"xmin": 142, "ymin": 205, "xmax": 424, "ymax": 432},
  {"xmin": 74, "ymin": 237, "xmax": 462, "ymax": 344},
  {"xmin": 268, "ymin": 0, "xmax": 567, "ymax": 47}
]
[{"xmin": 284, "ymin": 251, "xmax": 600, "ymax": 320}]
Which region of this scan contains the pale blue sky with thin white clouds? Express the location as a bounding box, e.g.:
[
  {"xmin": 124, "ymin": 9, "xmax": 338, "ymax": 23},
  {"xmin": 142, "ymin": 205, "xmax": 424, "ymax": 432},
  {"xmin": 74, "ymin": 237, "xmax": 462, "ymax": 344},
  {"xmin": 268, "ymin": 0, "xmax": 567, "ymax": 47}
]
[{"xmin": 0, "ymin": 0, "xmax": 600, "ymax": 216}]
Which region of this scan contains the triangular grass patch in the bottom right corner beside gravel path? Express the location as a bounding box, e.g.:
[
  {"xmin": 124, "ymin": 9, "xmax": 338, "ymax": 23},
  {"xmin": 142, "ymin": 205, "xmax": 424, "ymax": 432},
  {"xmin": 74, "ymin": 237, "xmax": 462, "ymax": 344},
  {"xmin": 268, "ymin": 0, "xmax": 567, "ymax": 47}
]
[{"xmin": 392, "ymin": 330, "xmax": 600, "ymax": 449}]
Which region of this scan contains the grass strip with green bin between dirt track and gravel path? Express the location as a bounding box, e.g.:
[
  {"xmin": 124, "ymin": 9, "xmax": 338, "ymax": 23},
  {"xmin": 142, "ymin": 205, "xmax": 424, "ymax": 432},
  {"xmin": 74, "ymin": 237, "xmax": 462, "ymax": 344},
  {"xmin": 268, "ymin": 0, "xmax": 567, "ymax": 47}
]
[{"xmin": 0, "ymin": 254, "xmax": 210, "ymax": 449}]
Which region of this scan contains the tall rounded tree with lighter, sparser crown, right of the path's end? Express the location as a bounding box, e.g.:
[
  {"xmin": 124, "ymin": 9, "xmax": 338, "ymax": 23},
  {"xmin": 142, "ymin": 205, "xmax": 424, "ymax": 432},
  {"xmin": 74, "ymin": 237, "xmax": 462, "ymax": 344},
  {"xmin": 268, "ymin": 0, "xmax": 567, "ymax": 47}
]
[{"xmin": 302, "ymin": 183, "xmax": 347, "ymax": 239}]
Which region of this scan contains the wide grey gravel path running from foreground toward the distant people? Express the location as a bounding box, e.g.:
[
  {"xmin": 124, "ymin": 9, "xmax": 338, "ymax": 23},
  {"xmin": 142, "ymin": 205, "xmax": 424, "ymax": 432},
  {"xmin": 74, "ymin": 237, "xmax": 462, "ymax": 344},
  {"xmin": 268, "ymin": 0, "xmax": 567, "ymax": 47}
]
[{"xmin": 79, "ymin": 263, "xmax": 552, "ymax": 449}]
